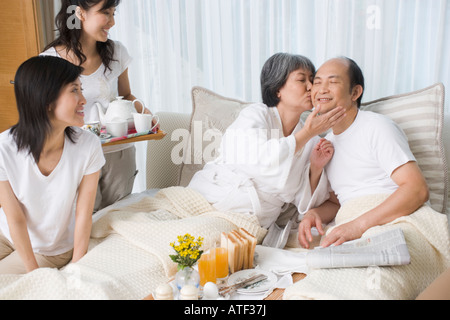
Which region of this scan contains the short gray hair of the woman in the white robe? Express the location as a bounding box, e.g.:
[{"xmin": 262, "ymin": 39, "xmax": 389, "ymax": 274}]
[{"xmin": 261, "ymin": 53, "xmax": 316, "ymax": 107}]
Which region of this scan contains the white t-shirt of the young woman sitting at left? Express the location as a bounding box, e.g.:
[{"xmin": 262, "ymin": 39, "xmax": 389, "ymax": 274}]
[{"xmin": 0, "ymin": 128, "xmax": 105, "ymax": 256}]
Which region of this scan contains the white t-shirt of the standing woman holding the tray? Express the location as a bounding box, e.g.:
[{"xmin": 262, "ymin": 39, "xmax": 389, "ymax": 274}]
[{"xmin": 41, "ymin": 41, "xmax": 133, "ymax": 153}]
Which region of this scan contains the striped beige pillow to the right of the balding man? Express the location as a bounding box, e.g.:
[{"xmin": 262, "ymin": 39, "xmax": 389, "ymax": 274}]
[{"xmin": 361, "ymin": 83, "xmax": 448, "ymax": 213}]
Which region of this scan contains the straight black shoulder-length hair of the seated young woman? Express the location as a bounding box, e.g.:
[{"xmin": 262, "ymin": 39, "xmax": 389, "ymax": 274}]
[{"xmin": 10, "ymin": 56, "xmax": 83, "ymax": 163}]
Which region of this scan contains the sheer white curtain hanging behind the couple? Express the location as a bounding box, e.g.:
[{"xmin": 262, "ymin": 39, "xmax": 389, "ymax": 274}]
[{"xmin": 111, "ymin": 0, "xmax": 450, "ymax": 192}]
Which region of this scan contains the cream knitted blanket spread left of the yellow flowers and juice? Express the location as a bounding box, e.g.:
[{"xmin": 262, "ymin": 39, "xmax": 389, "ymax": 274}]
[{"xmin": 0, "ymin": 187, "xmax": 266, "ymax": 299}]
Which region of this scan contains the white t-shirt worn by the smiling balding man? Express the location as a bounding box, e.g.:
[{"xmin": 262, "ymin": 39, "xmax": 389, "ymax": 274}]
[{"xmin": 326, "ymin": 111, "xmax": 416, "ymax": 205}]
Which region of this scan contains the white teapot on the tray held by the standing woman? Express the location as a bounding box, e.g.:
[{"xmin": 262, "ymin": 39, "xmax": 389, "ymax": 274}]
[{"xmin": 95, "ymin": 97, "xmax": 144, "ymax": 129}]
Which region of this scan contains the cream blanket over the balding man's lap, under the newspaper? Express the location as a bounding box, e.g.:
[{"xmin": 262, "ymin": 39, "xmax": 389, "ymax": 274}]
[{"xmin": 284, "ymin": 195, "xmax": 450, "ymax": 299}]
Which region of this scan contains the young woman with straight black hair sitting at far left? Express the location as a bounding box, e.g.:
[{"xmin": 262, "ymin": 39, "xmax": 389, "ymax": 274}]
[{"xmin": 0, "ymin": 57, "xmax": 105, "ymax": 274}]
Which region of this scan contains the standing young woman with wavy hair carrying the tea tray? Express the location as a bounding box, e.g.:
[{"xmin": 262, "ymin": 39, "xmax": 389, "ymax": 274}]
[{"xmin": 42, "ymin": 0, "xmax": 158, "ymax": 211}]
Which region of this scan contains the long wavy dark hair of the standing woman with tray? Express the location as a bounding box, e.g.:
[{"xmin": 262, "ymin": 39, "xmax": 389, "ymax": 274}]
[{"xmin": 44, "ymin": 0, "xmax": 121, "ymax": 72}]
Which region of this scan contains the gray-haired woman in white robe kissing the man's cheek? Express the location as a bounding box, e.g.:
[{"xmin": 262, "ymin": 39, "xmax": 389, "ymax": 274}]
[{"xmin": 189, "ymin": 53, "xmax": 345, "ymax": 246}]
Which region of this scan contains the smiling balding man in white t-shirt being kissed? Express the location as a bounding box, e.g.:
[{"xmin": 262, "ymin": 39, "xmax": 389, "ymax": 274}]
[{"xmin": 299, "ymin": 57, "xmax": 429, "ymax": 248}]
